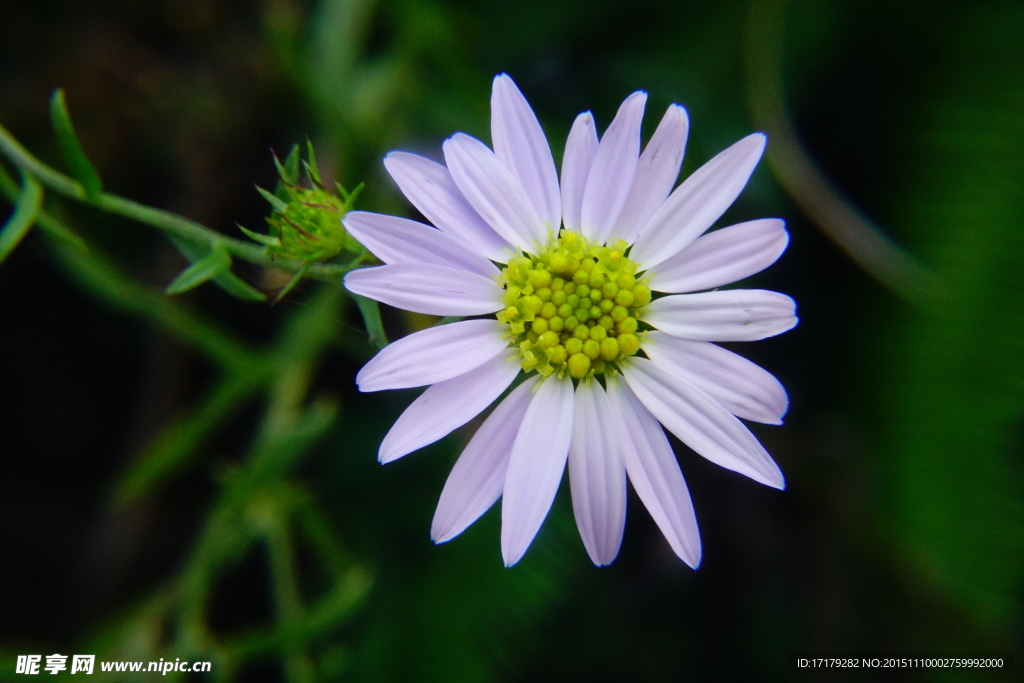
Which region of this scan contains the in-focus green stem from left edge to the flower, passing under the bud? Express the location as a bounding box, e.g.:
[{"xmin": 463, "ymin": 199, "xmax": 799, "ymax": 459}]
[{"xmin": 0, "ymin": 120, "xmax": 361, "ymax": 283}]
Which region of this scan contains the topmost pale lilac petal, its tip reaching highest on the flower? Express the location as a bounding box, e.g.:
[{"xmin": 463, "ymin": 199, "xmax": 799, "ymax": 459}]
[{"xmin": 490, "ymin": 74, "xmax": 562, "ymax": 232}]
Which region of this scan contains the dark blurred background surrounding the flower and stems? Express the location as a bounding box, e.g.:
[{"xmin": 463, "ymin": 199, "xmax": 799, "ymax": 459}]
[{"xmin": 0, "ymin": 0, "xmax": 1024, "ymax": 682}]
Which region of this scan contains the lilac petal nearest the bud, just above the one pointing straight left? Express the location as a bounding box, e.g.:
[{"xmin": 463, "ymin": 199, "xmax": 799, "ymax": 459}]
[{"xmin": 342, "ymin": 211, "xmax": 499, "ymax": 278}]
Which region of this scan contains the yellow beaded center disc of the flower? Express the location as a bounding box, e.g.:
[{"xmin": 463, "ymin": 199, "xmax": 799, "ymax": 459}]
[{"xmin": 498, "ymin": 229, "xmax": 650, "ymax": 379}]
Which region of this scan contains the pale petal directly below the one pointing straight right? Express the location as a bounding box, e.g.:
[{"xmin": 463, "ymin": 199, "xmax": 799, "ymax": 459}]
[{"xmin": 643, "ymin": 330, "xmax": 790, "ymax": 425}]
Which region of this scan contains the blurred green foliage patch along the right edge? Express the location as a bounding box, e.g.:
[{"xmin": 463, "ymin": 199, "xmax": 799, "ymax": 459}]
[{"xmin": 879, "ymin": 3, "xmax": 1024, "ymax": 627}]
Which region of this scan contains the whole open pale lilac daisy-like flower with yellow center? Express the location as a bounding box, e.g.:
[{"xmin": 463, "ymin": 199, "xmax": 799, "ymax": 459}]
[{"xmin": 345, "ymin": 74, "xmax": 797, "ymax": 567}]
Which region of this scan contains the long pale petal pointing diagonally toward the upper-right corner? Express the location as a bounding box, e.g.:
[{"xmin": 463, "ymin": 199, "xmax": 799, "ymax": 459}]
[{"xmin": 630, "ymin": 133, "xmax": 766, "ymax": 268}]
